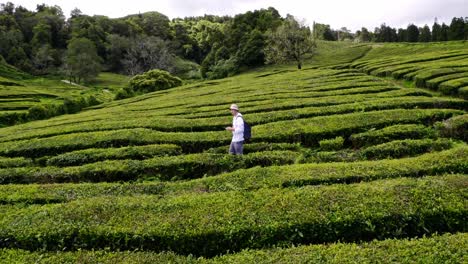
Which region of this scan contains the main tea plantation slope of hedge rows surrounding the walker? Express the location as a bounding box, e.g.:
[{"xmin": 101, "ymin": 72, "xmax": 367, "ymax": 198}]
[{"xmin": 0, "ymin": 42, "xmax": 468, "ymax": 263}]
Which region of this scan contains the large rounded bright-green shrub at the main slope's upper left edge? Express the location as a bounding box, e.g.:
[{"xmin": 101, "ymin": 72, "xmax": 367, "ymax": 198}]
[{"xmin": 129, "ymin": 70, "xmax": 182, "ymax": 92}]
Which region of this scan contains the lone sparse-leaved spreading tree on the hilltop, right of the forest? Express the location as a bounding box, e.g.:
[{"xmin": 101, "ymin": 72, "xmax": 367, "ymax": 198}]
[{"xmin": 265, "ymin": 15, "xmax": 316, "ymax": 69}]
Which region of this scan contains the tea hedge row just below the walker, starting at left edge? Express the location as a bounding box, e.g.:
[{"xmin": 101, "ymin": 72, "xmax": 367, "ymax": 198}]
[{"xmin": 0, "ymin": 149, "xmax": 299, "ymax": 184}]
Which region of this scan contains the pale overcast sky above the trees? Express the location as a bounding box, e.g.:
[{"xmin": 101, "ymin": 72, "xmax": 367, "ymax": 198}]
[{"xmin": 8, "ymin": 0, "xmax": 468, "ymax": 32}]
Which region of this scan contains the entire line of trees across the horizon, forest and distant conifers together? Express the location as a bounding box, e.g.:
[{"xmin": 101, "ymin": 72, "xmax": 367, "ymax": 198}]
[{"xmin": 0, "ymin": 2, "xmax": 468, "ymax": 83}]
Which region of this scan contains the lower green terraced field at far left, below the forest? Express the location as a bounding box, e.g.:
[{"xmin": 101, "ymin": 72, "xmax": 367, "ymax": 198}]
[{"xmin": 0, "ymin": 62, "xmax": 128, "ymax": 127}]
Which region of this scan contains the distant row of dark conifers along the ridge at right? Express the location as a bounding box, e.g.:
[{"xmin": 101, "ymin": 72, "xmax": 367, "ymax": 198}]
[{"xmin": 314, "ymin": 17, "xmax": 468, "ymax": 42}]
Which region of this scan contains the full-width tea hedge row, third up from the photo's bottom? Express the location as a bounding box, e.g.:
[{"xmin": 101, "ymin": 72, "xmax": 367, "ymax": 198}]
[{"xmin": 0, "ymin": 146, "xmax": 468, "ymax": 204}]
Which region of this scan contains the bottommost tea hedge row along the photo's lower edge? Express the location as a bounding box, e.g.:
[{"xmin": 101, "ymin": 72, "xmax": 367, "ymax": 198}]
[{"xmin": 0, "ymin": 233, "xmax": 468, "ymax": 264}]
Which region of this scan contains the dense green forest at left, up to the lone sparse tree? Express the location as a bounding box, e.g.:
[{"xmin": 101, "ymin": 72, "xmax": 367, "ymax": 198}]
[{"xmin": 0, "ymin": 2, "xmax": 285, "ymax": 82}]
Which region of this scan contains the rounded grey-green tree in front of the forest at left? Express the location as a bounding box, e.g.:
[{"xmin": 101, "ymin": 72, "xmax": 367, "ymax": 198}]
[{"xmin": 65, "ymin": 38, "xmax": 101, "ymax": 83}]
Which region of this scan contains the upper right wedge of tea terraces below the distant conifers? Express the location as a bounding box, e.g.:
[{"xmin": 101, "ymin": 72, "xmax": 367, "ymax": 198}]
[{"xmin": 351, "ymin": 41, "xmax": 468, "ymax": 99}]
